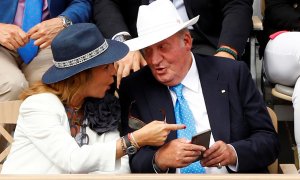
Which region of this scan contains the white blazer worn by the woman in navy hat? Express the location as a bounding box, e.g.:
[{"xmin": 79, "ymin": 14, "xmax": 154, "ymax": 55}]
[{"xmin": 1, "ymin": 93, "xmax": 130, "ymax": 174}]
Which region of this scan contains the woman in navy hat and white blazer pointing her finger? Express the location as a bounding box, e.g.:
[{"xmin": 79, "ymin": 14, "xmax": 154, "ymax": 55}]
[{"xmin": 2, "ymin": 23, "xmax": 184, "ymax": 174}]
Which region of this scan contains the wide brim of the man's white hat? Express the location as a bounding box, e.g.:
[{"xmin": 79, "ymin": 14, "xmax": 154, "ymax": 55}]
[{"xmin": 124, "ymin": 15, "xmax": 199, "ymax": 51}]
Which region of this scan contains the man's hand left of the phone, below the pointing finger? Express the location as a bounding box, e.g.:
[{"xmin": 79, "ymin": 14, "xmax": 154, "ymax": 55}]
[{"xmin": 155, "ymin": 139, "xmax": 206, "ymax": 170}]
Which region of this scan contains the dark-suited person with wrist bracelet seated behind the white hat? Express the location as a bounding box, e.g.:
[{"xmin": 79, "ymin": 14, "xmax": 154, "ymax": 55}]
[{"xmin": 94, "ymin": 0, "xmax": 253, "ymax": 87}]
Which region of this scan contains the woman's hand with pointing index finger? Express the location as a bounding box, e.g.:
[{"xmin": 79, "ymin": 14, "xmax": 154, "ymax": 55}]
[{"xmin": 133, "ymin": 121, "xmax": 186, "ymax": 147}]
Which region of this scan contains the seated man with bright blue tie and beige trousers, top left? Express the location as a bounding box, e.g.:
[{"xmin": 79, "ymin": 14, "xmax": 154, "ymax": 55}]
[{"xmin": 0, "ymin": 0, "xmax": 91, "ymax": 101}]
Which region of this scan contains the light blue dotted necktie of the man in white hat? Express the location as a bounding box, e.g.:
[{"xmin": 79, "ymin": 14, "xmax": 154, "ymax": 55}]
[{"xmin": 170, "ymin": 84, "xmax": 205, "ymax": 174}]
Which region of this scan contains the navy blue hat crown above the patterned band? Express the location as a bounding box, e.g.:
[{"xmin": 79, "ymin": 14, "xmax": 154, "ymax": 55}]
[{"xmin": 51, "ymin": 23, "xmax": 105, "ymax": 62}]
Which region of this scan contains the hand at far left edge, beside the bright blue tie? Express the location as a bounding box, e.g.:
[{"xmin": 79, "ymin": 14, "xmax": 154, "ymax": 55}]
[{"xmin": 0, "ymin": 23, "xmax": 29, "ymax": 51}]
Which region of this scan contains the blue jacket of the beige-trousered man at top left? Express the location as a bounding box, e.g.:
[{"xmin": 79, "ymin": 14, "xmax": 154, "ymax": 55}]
[{"xmin": 0, "ymin": 0, "xmax": 92, "ymax": 24}]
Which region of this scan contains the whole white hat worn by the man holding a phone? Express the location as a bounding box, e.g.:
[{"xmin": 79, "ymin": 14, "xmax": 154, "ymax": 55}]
[{"xmin": 124, "ymin": 0, "xmax": 199, "ymax": 51}]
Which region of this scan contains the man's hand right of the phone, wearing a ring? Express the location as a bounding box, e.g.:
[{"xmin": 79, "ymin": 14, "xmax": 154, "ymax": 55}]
[{"xmin": 201, "ymin": 141, "xmax": 237, "ymax": 167}]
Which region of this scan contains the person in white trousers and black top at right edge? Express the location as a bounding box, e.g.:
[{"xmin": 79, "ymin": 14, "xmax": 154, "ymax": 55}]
[{"xmin": 262, "ymin": 0, "xmax": 300, "ymax": 167}]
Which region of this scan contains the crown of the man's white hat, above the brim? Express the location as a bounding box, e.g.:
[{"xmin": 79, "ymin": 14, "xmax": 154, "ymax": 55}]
[{"xmin": 137, "ymin": 0, "xmax": 183, "ymax": 36}]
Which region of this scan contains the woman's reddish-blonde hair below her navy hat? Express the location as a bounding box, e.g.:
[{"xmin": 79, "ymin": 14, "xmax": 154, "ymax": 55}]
[{"xmin": 19, "ymin": 69, "xmax": 91, "ymax": 105}]
